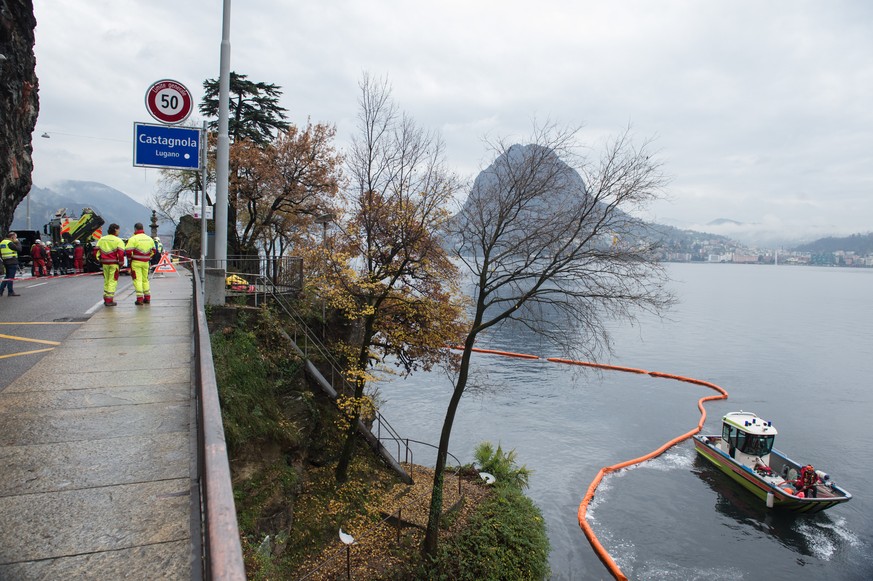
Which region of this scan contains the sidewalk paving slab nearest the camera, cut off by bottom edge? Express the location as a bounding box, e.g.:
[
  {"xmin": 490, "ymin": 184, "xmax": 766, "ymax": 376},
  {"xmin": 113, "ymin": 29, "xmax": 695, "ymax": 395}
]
[{"xmin": 0, "ymin": 541, "xmax": 192, "ymax": 581}]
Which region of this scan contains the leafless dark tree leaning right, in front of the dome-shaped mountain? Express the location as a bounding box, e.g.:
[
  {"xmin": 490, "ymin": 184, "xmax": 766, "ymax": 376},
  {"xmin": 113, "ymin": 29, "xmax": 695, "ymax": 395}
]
[{"xmin": 424, "ymin": 124, "xmax": 673, "ymax": 556}]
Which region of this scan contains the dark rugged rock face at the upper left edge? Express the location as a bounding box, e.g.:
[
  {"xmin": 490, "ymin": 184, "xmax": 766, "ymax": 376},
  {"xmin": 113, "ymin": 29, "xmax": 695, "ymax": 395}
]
[{"xmin": 0, "ymin": 0, "xmax": 39, "ymax": 235}]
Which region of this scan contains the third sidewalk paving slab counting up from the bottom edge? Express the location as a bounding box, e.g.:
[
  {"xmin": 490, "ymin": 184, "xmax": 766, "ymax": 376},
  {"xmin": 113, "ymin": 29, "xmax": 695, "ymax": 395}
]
[{"xmin": 0, "ymin": 432, "xmax": 191, "ymax": 494}]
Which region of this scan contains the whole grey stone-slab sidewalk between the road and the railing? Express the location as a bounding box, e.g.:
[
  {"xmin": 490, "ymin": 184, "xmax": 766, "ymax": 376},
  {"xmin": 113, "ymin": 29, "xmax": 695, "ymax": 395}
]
[{"xmin": 0, "ymin": 270, "xmax": 201, "ymax": 581}]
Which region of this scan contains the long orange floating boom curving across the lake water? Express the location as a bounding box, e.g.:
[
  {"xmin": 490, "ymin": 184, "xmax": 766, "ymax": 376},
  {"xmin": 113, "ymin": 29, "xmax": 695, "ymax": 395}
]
[{"xmin": 454, "ymin": 347, "xmax": 728, "ymax": 581}]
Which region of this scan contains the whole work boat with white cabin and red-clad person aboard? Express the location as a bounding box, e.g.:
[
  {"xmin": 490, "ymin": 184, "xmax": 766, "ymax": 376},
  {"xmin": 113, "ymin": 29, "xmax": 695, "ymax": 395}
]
[{"xmin": 694, "ymin": 411, "xmax": 852, "ymax": 513}]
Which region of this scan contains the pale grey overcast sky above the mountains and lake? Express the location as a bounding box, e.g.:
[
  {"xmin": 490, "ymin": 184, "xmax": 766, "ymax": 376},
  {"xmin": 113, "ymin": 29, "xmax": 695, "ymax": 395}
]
[{"xmin": 34, "ymin": 0, "xmax": 873, "ymax": 242}]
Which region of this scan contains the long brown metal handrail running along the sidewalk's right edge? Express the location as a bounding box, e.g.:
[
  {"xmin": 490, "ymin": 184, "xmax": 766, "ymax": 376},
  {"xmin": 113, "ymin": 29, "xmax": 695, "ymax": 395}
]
[{"xmin": 192, "ymin": 268, "xmax": 246, "ymax": 580}]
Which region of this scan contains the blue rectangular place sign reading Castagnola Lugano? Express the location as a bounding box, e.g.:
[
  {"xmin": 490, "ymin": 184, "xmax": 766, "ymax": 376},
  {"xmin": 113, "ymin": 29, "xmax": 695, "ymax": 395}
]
[{"xmin": 133, "ymin": 123, "xmax": 202, "ymax": 170}]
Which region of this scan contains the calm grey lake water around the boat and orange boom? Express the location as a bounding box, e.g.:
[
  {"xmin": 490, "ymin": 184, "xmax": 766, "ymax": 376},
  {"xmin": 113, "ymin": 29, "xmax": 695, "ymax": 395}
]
[{"xmin": 379, "ymin": 264, "xmax": 873, "ymax": 581}]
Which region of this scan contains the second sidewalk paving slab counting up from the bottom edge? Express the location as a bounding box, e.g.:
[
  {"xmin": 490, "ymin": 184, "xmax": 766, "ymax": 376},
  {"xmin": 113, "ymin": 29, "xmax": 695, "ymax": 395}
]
[{"xmin": 0, "ymin": 478, "xmax": 191, "ymax": 560}]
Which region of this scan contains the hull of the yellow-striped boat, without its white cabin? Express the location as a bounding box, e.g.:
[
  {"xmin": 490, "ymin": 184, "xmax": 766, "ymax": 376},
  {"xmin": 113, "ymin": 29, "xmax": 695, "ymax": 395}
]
[{"xmin": 694, "ymin": 435, "xmax": 852, "ymax": 513}]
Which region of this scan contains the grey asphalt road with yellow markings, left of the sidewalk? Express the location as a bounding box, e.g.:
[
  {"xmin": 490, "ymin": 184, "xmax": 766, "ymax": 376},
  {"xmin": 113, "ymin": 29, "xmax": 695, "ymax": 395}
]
[{"xmin": 0, "ymin": 273, "xmax": 132, "ymax": 391}]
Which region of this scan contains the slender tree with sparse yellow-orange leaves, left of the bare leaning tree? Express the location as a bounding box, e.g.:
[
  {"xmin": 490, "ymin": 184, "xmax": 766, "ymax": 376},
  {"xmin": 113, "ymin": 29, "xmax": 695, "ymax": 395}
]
[{"xmin": 321, "ymin": 75, "xmax": 463, "ymax": 482}]
